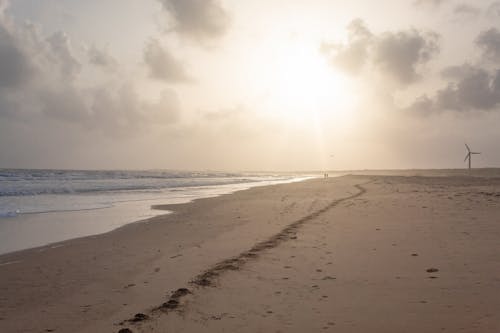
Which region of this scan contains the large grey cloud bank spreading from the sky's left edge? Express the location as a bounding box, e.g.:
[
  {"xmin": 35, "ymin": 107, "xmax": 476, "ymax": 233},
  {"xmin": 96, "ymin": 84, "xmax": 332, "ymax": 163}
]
[{"xmin": 0, "ymin": 4, "xmax": 180, "ymax": 136}]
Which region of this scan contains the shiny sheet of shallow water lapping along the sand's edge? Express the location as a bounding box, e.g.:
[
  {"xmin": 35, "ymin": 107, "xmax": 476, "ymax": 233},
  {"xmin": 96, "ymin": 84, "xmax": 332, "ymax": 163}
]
[{"xmin": 0, "ymin": 177, "xmax": 311, "ymax": 254}]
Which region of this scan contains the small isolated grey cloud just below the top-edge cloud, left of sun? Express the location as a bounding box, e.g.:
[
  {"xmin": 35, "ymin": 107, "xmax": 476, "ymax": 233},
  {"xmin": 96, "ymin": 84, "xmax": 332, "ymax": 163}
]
[{"xmin": 144, "ymin": 39, "xmax": 190, "ymax": 82}]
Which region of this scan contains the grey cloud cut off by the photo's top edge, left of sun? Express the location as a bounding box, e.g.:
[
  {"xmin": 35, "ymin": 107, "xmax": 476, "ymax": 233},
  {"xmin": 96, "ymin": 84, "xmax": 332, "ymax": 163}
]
[{"xmin": 158, "ymin": 0, "xmax": 230, "ymax": 41}]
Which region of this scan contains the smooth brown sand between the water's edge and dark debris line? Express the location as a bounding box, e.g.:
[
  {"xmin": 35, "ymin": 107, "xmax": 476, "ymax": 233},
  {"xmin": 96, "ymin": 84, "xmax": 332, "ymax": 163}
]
[{"xmin": 0, "ymin": 178, "xmax": 360, "ymax": 332}]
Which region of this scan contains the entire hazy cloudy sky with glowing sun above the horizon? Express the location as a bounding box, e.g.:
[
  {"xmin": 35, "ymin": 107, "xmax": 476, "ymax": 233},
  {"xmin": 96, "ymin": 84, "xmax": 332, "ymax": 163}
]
[{"xmin": 0, "ymin": 0, "xmax": 500, "ymax": 171}]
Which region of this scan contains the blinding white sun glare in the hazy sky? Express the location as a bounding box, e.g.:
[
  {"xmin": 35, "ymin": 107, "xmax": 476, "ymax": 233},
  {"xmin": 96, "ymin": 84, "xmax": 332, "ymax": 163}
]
[{"xmin": 252, "ymin": 34, "xmax": 354, "ymax": 120}]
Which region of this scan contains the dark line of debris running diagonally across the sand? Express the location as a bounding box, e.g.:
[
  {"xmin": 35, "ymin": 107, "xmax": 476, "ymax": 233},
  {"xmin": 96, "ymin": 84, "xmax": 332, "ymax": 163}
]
[{"xmin": 119, "ymin": 182, "xmax": 369, "ymax": 333}]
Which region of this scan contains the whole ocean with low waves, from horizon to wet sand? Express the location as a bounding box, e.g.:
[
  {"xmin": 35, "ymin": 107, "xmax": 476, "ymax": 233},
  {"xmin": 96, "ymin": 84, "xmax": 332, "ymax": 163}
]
[{"xmin": 0, "ymin": 169, "xmax": 308, "ymax": 254}]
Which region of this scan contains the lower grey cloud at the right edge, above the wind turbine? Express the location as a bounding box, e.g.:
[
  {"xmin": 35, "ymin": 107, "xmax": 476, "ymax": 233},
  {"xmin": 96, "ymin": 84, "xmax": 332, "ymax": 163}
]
[{"xmin": 408, "ymin": 64, "xmax": 500, "ymax": 113}]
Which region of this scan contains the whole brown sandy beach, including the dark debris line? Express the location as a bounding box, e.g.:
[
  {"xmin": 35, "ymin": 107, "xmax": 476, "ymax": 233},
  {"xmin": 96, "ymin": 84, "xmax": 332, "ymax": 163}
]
[{"xmin": 0, "ymin": 175, "xmax": 500, "ymax": 333}]
